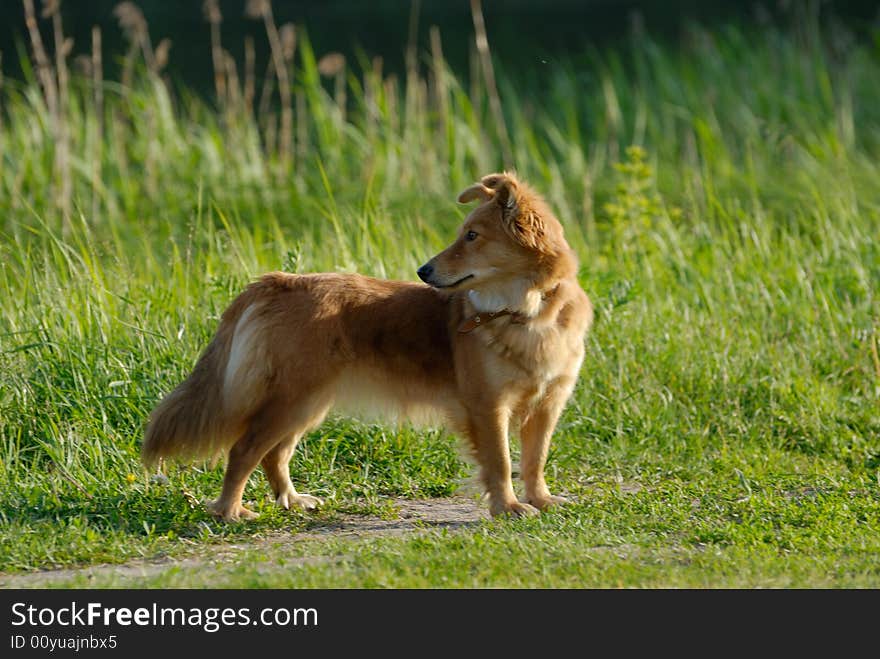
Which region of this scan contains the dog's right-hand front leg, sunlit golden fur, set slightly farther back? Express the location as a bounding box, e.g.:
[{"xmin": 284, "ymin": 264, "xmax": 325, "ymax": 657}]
[{"xmin": 520, "ymin": 380, "xmax": 574, "ymax": 510}]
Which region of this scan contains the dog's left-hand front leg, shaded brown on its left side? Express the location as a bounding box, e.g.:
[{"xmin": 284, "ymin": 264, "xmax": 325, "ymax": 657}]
[{"xmin": 468, "ymin": 409, "xmax": 538, "ymax": 517}]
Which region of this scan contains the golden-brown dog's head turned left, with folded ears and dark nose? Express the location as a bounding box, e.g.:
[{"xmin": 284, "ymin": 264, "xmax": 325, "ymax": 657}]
[{"xmin": 418, "ymin": 172, "xmax": 570, "ymax": 298}]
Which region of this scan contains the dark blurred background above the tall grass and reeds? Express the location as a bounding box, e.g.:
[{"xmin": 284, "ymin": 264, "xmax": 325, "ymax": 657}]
[{"xmin": 0, "ymin": 0, "xmax": 880, "ymax": 89}]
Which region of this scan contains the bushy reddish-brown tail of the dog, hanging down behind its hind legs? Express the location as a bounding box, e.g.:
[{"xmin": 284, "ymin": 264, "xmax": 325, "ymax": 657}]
[{"xmin": 141, "ymin": 284, "xmax": 268, "ymax": 467}]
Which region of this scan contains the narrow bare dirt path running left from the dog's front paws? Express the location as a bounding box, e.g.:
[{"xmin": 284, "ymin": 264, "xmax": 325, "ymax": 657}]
[{"xmin": 0, "ymin": 497, "xmax": 489, "ymax": 588}]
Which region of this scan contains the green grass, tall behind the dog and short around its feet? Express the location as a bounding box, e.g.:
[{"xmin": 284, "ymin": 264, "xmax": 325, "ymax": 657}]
[{"xmin": 0, "ymin": 6, "xmax": 880, "ymax": 588}]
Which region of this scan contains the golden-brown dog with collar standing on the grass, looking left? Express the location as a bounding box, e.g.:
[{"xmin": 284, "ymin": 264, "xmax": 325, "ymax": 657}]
[{"xmin": 142, "ymin": 172, "xmax": 593, "ymax": 521}]
